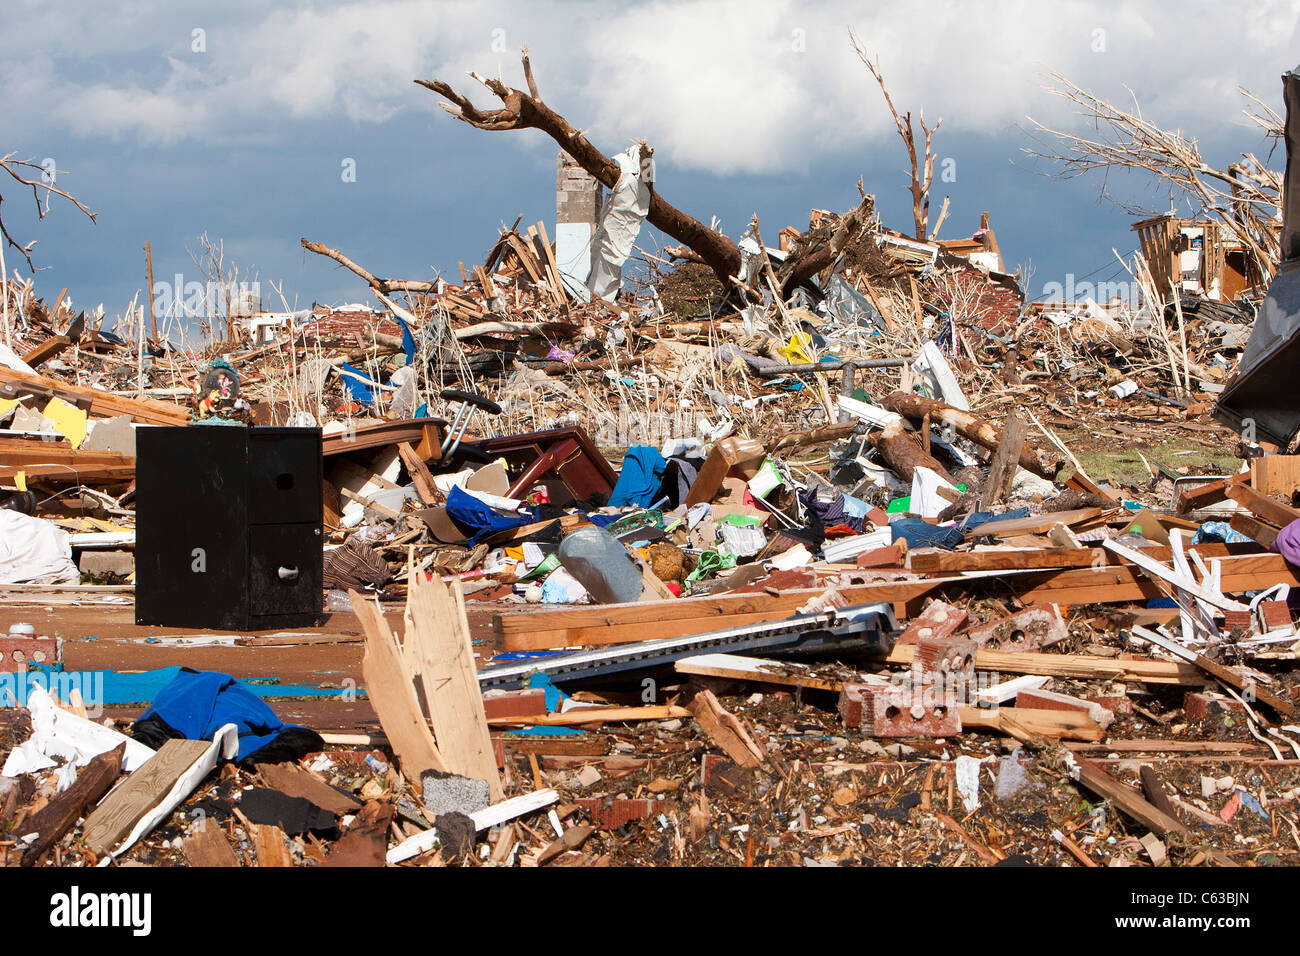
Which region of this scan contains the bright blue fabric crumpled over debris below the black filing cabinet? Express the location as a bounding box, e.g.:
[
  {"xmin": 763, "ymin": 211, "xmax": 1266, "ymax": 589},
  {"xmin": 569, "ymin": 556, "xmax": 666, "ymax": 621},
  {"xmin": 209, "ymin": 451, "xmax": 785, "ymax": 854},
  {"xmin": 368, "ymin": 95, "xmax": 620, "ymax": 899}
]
[{"xmin": 140, "ymin": 667, "xmax": 309, "ymax": 760}]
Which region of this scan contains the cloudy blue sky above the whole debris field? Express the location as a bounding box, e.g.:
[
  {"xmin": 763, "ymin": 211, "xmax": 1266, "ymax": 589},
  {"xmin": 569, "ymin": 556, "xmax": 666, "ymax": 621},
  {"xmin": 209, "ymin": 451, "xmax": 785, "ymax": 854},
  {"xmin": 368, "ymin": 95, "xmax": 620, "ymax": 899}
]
[{"xmin": 0, "ymin": 0, "xmax": 1300, "ymax": 335}]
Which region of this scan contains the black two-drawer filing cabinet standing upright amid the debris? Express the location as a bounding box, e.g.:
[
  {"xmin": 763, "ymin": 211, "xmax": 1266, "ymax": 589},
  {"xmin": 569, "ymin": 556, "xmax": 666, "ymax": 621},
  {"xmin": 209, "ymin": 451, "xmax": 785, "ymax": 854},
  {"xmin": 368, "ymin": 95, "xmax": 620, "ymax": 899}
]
[{"xmin": 135, "ymin": 425, "xmax": 324, "ymax": 631}]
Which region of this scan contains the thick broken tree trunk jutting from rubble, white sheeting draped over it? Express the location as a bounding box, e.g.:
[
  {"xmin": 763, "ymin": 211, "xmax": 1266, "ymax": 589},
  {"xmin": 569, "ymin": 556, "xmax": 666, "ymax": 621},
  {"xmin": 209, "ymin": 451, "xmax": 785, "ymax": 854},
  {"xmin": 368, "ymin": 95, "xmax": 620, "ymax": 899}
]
[{"xmin": 416, "ymin": 47, "xmax": 870, "ymax": 303}]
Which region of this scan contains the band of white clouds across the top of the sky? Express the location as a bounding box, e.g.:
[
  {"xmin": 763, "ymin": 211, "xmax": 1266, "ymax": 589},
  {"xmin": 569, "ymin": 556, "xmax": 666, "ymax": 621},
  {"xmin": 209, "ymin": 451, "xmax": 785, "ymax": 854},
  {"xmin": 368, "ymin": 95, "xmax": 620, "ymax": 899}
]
[{"xmin": 0, "ymin": 0, "xmax": 1300, "ymax": 167}]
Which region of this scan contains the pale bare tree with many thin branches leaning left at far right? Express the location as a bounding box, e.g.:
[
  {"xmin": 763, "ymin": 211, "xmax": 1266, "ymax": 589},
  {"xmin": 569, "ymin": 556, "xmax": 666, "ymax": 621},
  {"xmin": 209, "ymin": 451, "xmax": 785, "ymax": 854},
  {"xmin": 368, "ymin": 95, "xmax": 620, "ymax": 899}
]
[{"xmin": 1024, "ymin": 73, "xmax": 1282, "ymax": 283}]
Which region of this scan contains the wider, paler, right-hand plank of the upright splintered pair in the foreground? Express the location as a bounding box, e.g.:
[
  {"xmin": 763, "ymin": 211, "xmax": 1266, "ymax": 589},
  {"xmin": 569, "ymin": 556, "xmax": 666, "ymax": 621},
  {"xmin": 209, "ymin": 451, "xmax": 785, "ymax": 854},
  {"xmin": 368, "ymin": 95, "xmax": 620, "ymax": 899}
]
[{"xmin": 406, "ymin": 575, "xmax": 503, "ymax": 803}]
